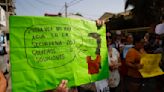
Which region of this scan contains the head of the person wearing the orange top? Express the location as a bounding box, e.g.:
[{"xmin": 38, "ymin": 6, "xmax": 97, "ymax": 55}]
[{"xmin": 134, "ymin": 34, "xmax": 144, "ymax": 50}]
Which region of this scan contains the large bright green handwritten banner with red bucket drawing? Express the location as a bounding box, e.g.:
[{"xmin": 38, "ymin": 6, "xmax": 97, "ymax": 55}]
[{"xmin": 10, "ymin": 16, "xmax": 109, "ymax": 92}]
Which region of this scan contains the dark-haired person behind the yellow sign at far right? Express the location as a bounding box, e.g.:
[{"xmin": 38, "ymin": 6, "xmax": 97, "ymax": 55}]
[{"xmin": 144, "ymin": 33, "xmax": 164, "ymax": 92}]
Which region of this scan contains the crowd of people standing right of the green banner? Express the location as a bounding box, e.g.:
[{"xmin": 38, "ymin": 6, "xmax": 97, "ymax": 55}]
[{"xmin": 76, "ymin": 18, "xmax": 164, "ymax": 92}]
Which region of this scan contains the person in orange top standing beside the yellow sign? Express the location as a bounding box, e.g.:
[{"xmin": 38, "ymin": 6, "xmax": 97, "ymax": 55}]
[{"xmin": 125, "ymin": 35, "xmax": 144, "ymax": 92}]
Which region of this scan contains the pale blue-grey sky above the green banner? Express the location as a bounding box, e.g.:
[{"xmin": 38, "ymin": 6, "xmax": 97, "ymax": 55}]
[{"xmin": 15, "ymin": 0, "xmax": 125, "ymax": 20}]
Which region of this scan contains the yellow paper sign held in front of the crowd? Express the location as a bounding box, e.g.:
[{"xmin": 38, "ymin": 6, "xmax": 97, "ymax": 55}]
[{"xmin": 139, "ymin": 54, "xmax": 164, "ymax": 78}]
